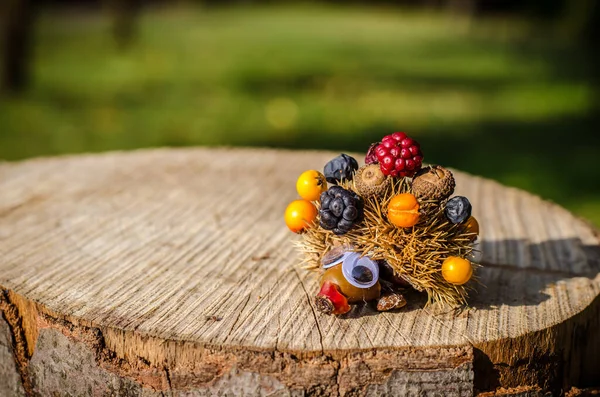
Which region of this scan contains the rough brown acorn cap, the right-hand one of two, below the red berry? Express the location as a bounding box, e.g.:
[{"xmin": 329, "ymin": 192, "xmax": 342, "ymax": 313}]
[{"xmin": 412, "ymin": 165, "xmax": 456, "ymax": 201}]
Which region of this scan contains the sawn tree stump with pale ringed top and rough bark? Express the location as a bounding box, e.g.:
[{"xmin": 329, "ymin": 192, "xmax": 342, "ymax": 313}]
[{"xmin": 0, "ymin": 149, "xmax": 600, "ymax": 396}]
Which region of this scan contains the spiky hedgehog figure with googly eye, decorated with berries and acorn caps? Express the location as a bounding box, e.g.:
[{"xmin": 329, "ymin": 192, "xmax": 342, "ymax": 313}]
[{"xmin": 285, "ymin": 132, "xmax": 481, "ymax": 314}]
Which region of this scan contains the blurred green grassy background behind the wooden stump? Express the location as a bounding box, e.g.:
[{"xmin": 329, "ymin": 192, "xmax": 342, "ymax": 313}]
[{"xmin": 0, "ymin": 0, "xmax": 600, "ymax": 226}]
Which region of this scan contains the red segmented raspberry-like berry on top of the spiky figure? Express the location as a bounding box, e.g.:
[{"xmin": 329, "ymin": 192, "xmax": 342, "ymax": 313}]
[{"xmin": 376, "ymin": 132, "xmax": 423, "ymax": 177}]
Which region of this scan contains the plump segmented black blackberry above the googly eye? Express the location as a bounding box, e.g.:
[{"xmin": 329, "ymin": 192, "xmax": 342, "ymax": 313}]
[{"xmin": 319, "ymin": 186, "xmax": 364, "ymax": 235}]
